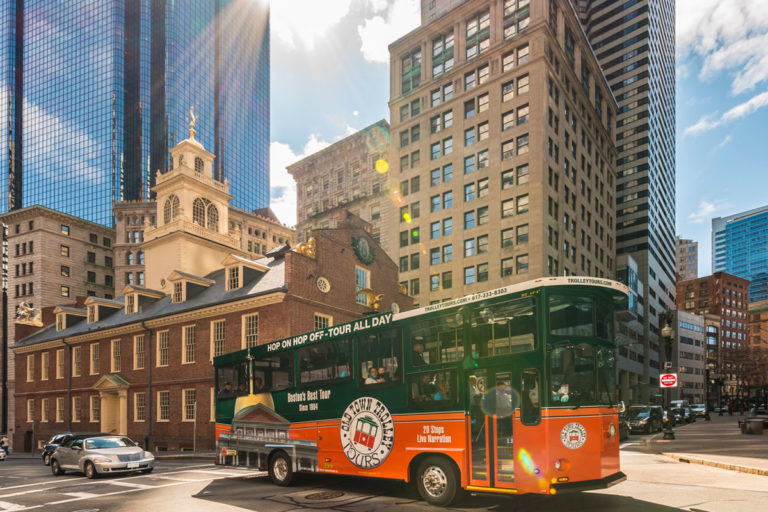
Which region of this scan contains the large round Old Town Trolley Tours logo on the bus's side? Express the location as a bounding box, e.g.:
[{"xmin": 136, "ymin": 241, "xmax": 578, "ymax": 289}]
[{"xmin": 340, "ymin": 397, "xmax": 395, "ymax": 469}]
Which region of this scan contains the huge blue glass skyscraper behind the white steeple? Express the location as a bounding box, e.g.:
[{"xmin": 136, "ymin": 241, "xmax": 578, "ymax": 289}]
[{"xmin": 0, "ymin": 0, "xmax": 269, "ymax": 225}]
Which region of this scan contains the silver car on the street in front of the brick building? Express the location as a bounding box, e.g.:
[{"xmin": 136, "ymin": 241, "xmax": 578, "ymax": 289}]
[{"xmin": 51, "ymin": 436, "xmax": 155, "ymax": 478}]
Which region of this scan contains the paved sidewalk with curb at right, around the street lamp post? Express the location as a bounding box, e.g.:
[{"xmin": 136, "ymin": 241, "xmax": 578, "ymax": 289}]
[{"xmin": 648, "ymin": 413, "xmax": 768, "ymax": 476}]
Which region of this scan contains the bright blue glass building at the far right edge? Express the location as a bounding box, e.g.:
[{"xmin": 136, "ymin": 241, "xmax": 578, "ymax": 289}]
[{"xmin": 712, "ymin": 206, "xmax": 768, "ymax": 302}]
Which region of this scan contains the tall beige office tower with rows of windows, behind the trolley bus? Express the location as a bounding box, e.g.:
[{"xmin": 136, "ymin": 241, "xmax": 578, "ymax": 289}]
[{"xmin": 389, "ymin": 0, "xmax": 616, "ymax": 305}]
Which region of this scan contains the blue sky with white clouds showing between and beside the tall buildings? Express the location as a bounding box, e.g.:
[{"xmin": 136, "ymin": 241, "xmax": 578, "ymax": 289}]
[{"xmin": 270, "ymin": 0, "xmax": 768, "ymax": 276}]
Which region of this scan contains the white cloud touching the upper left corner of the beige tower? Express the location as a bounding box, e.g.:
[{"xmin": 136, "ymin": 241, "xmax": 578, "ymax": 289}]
[{"xmin": 357, "ymin": 0, "xmax": 421, "ymax": 64}]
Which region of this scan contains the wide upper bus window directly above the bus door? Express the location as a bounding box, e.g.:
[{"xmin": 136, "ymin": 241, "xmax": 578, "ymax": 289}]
[{"xmin": 470, "ymin": 298, "xmax": 536, "ymax": 357}]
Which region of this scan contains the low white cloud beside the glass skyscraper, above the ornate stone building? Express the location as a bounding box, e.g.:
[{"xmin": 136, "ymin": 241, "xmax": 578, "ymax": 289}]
[{"xmin": 269, "ymin": 133, "xmax": 330, "ymax": 226}]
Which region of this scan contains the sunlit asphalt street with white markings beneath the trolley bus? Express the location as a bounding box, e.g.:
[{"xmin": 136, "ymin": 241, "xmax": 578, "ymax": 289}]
[{"xmin": 0, "ymin": 424, "xmax": 768, "ymax": 512}]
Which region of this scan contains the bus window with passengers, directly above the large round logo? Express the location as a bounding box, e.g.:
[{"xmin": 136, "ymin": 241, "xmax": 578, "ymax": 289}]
[{"xmin": 357, "ymin": 328, "xmax": 403, "ymax": 387}]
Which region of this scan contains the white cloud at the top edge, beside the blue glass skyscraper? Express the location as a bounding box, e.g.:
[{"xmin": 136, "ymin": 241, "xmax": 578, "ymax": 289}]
[{"xmin": 269, "ymin": 0, "xmax": 352, "ymax": 50}]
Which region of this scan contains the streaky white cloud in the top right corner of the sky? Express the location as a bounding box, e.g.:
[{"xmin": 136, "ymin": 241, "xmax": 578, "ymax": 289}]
[{"xmin": 676, "ymin": 0, "xmax": 768, "ymax": 94}]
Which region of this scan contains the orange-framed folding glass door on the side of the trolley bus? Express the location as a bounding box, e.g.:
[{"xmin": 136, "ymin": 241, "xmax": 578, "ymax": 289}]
[{"xmin": 468, "ymin": 370, "xmax": 517, "ymax": 488}]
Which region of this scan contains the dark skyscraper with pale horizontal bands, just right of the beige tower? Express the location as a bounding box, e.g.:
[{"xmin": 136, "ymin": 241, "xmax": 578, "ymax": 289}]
[{"xmin": 571, "ymin": 0, "xmax": 676, "ymax": 400}]
